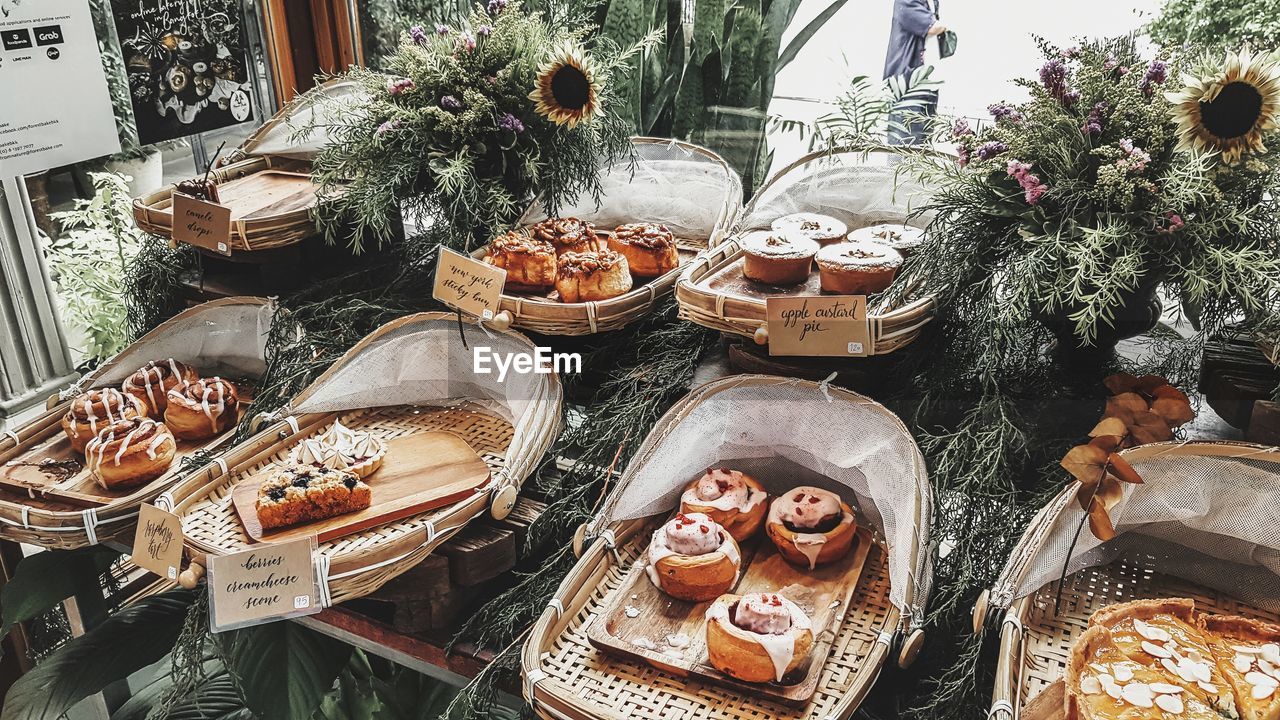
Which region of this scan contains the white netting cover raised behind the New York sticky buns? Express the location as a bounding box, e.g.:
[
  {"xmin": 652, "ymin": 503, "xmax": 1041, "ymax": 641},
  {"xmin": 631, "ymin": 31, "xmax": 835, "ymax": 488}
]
[{"xmin": 520, "ymin": 140, "xmax": 742, "ymax": 243}]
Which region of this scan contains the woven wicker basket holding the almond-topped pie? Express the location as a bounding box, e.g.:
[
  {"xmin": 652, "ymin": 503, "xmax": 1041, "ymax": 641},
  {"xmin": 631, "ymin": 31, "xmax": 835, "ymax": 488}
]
[{"xmin": 974, "ymin": 442, "xmax": 1280, "ymax": 720}]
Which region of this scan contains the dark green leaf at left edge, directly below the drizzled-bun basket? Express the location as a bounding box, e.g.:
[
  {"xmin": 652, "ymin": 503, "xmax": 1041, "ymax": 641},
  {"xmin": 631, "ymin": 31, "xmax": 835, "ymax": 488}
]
[{"xmin": 0, "ymin": 544, "xmax": 120, "ymax": 639}]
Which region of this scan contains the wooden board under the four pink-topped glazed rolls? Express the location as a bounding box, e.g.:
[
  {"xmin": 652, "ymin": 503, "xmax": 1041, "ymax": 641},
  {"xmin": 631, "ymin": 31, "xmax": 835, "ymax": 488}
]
[{"xmin": 586, "ymin": 517, "xmax": 873, "ymax": 707}]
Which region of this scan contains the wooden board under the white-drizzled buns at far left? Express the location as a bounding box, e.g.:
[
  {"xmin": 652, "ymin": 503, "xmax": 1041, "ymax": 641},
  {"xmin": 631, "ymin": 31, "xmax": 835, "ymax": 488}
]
[{"xmin": 0, "ymin": 382, "xmax": 252, "ymax": 510}]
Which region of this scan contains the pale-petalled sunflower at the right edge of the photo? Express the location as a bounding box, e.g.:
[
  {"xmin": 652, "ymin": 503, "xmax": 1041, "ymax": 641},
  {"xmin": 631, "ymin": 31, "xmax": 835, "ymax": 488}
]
[{"xmin": 1166, "ymin": 50, "xmax": 1280, "ymax": 165}]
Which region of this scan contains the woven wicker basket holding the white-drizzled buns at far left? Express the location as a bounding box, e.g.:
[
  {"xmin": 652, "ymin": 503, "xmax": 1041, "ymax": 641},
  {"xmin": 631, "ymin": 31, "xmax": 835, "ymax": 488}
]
[{"xmin": 0, "ymin": 297, "xmax": 274, "ymax": 550}]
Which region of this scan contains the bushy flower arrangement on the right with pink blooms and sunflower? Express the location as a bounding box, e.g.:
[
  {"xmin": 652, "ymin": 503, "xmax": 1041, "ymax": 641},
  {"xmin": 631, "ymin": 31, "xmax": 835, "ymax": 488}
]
[{"xmin": 905, "ymin": 38, "xmax": 1280, "ymax": 359}]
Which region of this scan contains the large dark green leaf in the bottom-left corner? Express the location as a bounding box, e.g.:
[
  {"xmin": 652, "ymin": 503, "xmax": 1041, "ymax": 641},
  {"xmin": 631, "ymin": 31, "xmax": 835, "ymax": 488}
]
[{"xmin": 0, "ymin": 589, "xmax": 195, "ymax": 720}]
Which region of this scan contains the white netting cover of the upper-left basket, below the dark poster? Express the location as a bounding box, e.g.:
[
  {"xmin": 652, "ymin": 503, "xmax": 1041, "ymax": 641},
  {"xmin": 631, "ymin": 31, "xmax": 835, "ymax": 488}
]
[{"xmin": 241, "ymin": 81, "xmax": 369, "ymax": 160}]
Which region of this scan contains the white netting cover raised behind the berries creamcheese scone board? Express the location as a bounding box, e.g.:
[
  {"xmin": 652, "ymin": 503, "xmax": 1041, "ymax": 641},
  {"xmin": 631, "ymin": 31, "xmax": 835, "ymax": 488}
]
[{"xmin": 293, "ymin": 316, "xmax": 550, "ymax": 425}]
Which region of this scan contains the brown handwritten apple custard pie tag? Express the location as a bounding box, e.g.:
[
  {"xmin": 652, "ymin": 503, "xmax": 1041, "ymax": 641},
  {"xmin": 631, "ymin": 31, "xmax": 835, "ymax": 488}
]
[{"xmin": 765, "ymin": 295, "xmax": 870, "ymax": 357}]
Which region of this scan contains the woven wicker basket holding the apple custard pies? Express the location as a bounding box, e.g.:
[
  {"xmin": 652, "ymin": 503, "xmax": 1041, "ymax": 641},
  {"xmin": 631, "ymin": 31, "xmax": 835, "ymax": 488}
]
[{"xmin": 676, "ymin": 147, "xmax": 934, "ymax": 355}]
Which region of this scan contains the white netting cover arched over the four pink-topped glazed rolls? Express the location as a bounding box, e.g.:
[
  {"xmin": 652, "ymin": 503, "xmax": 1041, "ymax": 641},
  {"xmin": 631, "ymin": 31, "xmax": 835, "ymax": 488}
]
[{"xmin": 603, "ymin": 380, "xmax": 931, "ymax": 616}]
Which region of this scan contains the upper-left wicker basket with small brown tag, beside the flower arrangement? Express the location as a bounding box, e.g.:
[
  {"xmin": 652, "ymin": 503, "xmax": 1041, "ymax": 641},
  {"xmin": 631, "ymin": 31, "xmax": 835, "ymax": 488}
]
[{"xmin": 133, "ymin": 79, "xmax": 356, "ymax": 252}]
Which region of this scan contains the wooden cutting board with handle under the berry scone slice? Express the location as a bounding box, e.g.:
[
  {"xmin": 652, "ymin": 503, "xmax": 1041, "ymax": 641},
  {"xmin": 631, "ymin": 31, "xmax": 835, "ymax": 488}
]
[{"xmin": 232, "ymin": 432, "xmax": 489, "ymax": 542}]
